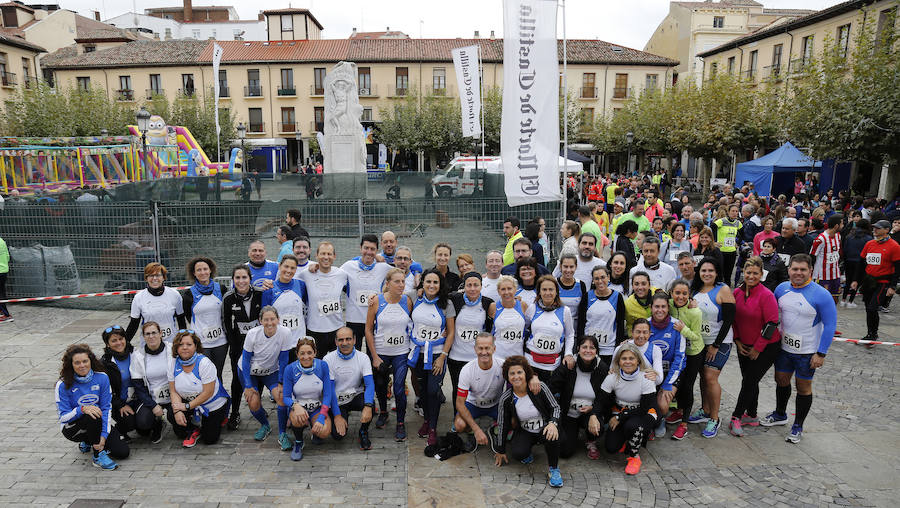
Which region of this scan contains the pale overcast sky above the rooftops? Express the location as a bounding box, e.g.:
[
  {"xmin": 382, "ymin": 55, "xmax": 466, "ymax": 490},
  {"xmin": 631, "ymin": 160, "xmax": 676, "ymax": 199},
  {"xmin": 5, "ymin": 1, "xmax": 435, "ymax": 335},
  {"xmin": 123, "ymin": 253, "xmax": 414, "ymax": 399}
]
[{"xmin": 67, "ymin": 0, "xmax": 839, "ymax": 49}]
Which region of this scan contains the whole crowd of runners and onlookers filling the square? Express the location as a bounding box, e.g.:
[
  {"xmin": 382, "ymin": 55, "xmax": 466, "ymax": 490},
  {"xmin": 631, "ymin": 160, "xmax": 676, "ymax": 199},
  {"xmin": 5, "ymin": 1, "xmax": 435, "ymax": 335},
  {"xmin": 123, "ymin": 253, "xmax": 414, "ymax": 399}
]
[{"xmin": 56, "ymin": 176, "xmax": 900, "ymax": 487}]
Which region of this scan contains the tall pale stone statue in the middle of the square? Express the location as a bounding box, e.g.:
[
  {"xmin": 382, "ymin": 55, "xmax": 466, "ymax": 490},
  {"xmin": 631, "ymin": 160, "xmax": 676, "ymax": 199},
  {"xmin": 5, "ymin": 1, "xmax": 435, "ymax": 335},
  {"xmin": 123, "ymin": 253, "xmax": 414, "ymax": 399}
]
[{"xmin": 322, "ymin": 62, "xmax": 366, "ymax": 173}]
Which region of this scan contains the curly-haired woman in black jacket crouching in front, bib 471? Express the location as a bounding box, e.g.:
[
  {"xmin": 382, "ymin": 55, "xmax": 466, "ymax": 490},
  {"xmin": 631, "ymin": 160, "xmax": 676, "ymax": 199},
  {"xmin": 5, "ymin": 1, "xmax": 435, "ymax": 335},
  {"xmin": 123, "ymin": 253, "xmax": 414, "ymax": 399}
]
[{"xmin": 494, "ymin": 355, "xmax": 563, "ymax": 488}]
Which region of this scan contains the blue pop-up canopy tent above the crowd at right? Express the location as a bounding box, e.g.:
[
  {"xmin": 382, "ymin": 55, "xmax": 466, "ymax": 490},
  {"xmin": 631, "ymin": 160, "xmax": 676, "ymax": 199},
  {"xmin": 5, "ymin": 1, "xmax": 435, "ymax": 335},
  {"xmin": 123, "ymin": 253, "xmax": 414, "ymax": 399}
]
[{"xmin": 734, "ymin": 143, "xmax": 822, "ymax": 196}]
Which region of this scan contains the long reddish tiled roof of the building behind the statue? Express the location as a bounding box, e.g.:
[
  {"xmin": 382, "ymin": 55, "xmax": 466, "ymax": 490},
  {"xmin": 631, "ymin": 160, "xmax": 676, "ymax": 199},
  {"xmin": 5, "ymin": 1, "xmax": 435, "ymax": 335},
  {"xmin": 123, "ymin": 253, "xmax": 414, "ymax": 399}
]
[{"xmin": 42, "ymin": 39, "xmax": 678, "ymax": 69}]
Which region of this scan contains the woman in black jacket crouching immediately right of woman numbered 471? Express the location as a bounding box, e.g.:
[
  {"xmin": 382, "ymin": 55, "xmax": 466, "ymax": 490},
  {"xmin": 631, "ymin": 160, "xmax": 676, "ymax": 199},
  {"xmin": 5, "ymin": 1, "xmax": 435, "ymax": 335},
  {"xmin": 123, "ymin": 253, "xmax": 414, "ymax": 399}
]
[{"xmin": 550, "ymin": 335, "xmax": 609, "ymax": 460}]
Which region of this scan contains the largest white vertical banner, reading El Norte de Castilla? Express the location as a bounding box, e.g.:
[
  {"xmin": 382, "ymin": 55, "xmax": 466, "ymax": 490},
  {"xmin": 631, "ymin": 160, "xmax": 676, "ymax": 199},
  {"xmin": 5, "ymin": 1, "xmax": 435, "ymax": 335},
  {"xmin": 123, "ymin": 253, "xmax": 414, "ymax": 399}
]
[{"xmin": 500, "ymin": 0, "xmax": 562, "ymax": 206}]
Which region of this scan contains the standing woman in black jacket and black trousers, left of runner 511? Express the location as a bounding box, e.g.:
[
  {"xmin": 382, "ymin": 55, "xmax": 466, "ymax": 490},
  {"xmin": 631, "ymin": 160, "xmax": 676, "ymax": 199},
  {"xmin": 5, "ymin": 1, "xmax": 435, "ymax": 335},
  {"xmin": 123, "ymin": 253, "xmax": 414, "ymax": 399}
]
[{"xmin": 222, "ymin": 265, "xmax": 262, "ymax": 430}]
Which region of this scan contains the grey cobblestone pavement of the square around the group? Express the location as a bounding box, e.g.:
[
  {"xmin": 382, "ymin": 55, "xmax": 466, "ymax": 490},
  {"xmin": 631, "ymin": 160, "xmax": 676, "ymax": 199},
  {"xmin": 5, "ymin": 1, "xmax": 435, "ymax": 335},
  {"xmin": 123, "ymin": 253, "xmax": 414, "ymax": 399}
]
[{"xmin": 0, "ymin": 305, "xmax": 900, "ymax": 507}]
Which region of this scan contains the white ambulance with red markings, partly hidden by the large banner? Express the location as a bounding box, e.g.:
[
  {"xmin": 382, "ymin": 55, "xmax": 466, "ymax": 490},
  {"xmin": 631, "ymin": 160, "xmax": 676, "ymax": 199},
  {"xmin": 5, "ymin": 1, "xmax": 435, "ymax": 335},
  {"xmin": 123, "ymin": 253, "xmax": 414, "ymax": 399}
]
[{"xmin": 431, "ymin": 155, "xmax": 583, "ymax": 198}]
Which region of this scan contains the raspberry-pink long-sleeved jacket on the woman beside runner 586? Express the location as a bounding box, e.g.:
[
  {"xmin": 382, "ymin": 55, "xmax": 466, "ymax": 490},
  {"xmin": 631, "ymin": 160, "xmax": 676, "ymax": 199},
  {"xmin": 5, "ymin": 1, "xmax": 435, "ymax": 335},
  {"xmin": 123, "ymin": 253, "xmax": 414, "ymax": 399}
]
[{"xmin": 732, "ymin": 284, "xmax": 781, "ymax": 352}]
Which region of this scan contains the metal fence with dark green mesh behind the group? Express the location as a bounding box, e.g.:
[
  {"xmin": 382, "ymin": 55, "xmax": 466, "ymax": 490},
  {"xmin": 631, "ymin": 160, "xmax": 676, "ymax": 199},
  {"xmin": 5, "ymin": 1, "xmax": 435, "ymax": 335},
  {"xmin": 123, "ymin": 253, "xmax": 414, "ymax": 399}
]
[{"xmin": 0, "ymin": 197, "xmax": 560, "ymax": 308}]
